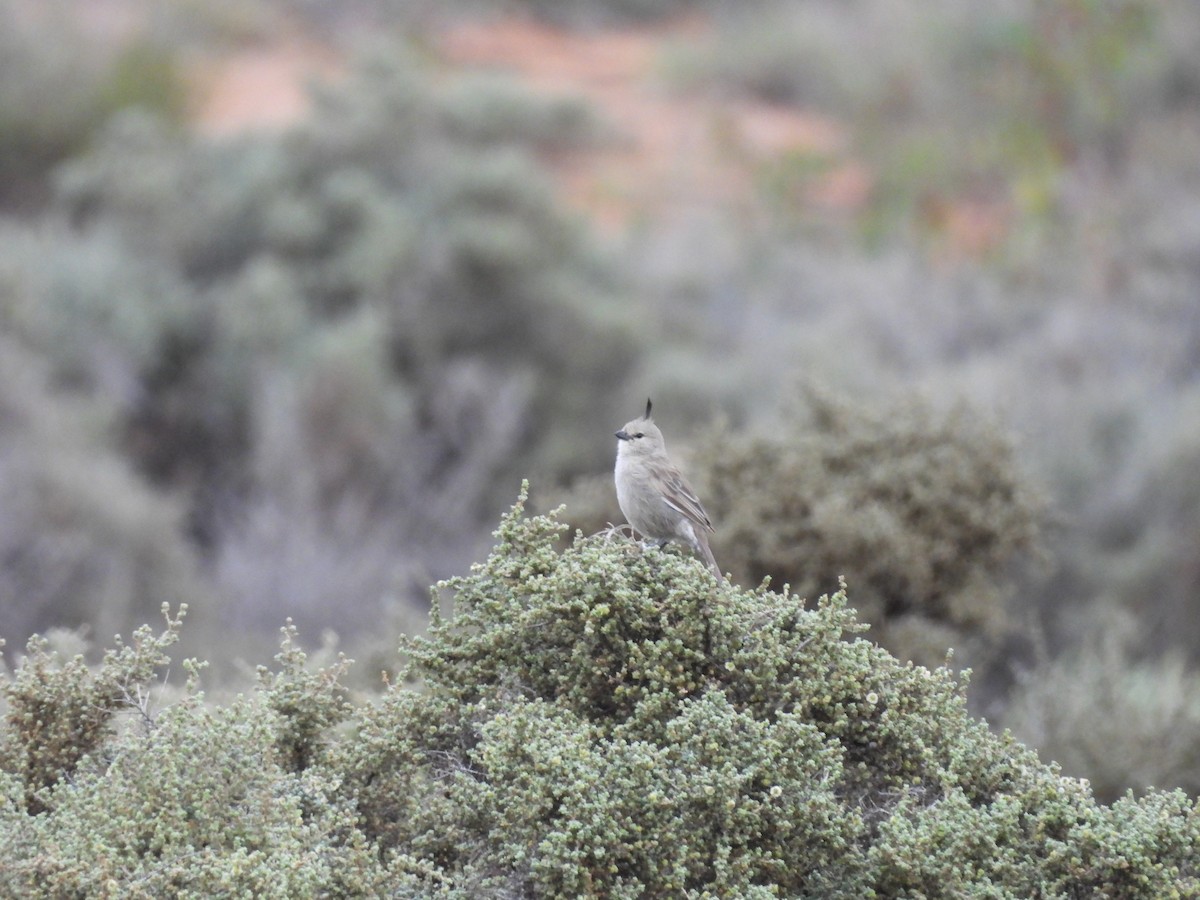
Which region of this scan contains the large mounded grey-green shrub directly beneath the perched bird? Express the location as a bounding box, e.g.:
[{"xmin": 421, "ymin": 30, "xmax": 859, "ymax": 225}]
[{"xmin": 333, "ymin": 494, "xmax": 1200, "ymax": 898}]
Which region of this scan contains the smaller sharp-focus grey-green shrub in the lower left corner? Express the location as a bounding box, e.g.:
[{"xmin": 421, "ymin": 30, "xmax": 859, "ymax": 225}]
[{"xmin": 0, "ymin": 622, "xmax": 395, "ymax": 899}]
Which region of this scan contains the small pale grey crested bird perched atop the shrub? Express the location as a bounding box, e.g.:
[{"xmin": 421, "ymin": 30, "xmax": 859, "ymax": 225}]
[{"xmin": 614, "ymin": 398, "xmax": 724, "ymax": 580}]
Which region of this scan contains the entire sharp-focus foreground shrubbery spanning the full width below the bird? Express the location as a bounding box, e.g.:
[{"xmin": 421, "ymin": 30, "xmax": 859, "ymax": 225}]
[{"xmin": 0, "ymin": 506, "xmax": 1200, "ymax": 899}]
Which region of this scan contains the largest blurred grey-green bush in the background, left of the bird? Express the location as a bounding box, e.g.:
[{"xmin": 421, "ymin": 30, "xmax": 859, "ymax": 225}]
[{"xmin": 0, "ymin": 47, "xmax": 638, "ymax": 648}]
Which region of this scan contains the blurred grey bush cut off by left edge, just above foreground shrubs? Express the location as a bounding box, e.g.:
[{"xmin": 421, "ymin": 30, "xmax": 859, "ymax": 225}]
[{"xmin": 0, "ymin": 337, "xmax": 204, "ymax": 636}]
